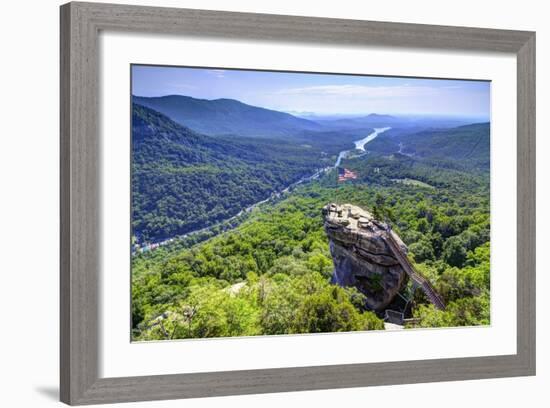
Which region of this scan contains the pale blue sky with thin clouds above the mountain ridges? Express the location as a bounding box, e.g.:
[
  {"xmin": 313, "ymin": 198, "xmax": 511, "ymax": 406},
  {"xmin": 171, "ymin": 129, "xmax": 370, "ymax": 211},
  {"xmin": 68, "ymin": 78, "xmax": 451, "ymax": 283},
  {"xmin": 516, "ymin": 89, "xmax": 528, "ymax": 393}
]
[{"xmin": 132, "ymin": 65, "xmax": 490, "ymax": 119}]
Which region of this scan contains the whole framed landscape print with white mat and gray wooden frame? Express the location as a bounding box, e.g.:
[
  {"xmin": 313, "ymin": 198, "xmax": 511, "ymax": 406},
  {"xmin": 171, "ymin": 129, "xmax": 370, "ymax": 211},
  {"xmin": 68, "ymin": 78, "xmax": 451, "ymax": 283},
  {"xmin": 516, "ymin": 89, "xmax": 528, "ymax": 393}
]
[{"xmin": 61, "ymin": 3, "xmax": 535, "ymax": 404}]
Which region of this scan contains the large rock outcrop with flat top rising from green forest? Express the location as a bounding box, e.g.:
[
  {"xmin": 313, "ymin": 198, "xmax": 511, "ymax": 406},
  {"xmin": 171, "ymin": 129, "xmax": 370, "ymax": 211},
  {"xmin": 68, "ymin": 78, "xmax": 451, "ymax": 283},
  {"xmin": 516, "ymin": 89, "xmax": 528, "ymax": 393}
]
[{"xmin": 323, "ymin": 204, "xmax": 407, "ymax": 311}]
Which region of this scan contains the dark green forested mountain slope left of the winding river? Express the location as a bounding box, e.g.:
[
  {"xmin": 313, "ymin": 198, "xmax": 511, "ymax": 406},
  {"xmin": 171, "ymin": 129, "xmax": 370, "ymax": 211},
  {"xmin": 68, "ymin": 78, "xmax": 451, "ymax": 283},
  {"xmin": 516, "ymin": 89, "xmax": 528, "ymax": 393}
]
[{"xmin": 132, "ymin": 104, "xmax": 331, "ymax": 241}]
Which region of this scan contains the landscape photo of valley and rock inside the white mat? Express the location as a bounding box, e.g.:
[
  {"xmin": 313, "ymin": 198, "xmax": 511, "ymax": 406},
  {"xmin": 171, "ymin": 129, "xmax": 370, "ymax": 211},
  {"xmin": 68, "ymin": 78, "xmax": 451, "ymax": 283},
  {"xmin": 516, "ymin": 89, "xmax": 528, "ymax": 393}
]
[{"xmin": 132, "ymin": 64, "xmax": 491, "ymax": 342}]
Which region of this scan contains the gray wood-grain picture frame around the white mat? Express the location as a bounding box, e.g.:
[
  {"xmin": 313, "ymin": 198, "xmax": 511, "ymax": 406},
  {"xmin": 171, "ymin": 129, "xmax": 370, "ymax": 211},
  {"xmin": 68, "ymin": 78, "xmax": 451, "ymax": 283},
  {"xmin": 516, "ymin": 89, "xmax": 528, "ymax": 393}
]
[{"xmin": 60, "ymin": 3, "xmax": 535, "ymax": 405}]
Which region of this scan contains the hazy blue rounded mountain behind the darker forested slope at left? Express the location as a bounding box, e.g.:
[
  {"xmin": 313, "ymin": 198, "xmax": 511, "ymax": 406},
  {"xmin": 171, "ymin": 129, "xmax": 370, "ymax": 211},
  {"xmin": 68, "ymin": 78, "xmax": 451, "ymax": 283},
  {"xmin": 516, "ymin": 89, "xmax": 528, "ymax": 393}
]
[{"xmin": 132, "ymin": 95, "xmax": 323, "ymax": 138}]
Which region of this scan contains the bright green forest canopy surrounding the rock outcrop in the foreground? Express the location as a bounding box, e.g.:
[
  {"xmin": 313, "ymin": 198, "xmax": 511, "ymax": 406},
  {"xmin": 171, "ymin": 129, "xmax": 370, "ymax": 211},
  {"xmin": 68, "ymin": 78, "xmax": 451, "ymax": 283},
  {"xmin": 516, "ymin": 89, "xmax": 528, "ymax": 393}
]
[{"xmin": 132, "ymin": 155, "xmax": 490, "ymax": 340}]
